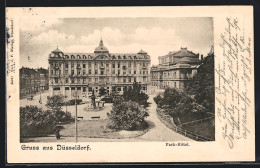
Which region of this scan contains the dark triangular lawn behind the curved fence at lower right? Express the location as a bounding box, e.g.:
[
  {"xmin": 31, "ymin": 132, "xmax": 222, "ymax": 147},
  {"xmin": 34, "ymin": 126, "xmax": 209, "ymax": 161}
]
[{"xmin": 182, "ymin": 118, "xmax": 215, "ymax": 140}]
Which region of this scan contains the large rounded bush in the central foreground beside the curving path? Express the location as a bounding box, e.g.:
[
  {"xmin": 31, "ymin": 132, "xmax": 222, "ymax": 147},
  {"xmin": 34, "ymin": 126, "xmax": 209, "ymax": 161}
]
[{"xmin": 108, "ymin": 98, "xmax": 149, "ymax": 131}]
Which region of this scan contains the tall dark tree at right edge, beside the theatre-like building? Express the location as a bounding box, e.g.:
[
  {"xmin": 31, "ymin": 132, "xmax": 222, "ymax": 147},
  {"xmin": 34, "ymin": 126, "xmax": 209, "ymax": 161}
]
[{"xmin": 186, "ymin": 53, "xmax": 215, "ymax": 112}]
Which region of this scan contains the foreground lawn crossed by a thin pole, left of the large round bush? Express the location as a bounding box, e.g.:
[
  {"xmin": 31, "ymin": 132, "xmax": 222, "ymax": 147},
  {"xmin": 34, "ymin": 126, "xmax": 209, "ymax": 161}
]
[{"xmin": 60, "ymin": 119, "xmax": 148, "ymax": 139}]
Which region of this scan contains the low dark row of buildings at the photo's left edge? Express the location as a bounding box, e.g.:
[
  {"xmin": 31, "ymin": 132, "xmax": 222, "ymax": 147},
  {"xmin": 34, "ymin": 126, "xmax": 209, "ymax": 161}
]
[{"xmin": 19, "ymin": 67, "xmax": 49, "ymax": 97}]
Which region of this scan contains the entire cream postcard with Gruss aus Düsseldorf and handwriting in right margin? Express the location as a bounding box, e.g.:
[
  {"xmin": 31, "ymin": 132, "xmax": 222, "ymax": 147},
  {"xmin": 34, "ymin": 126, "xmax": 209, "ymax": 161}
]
[{"xmin": 6, "ymin": 6, "xmax": 255, "ymax": 163}]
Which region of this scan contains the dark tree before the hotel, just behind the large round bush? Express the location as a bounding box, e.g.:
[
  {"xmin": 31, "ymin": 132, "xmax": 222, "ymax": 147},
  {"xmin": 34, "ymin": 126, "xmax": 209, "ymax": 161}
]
[{"xmin": 123, "ymin": 82, "xmax": 149, "ymax": 107}]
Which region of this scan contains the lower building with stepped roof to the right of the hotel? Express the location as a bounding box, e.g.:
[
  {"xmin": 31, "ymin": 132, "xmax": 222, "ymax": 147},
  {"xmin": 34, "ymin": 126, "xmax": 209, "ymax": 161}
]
[{"xmin": 151, "ymin": 48, "xmax": 203, "ymax": 90}]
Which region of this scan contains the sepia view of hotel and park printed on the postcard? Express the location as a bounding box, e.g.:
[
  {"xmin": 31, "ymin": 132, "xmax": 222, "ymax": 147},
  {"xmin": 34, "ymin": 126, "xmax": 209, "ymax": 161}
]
[{"xmin": 19, "ymin": 17, "xmax": 215, "ymax": 142}]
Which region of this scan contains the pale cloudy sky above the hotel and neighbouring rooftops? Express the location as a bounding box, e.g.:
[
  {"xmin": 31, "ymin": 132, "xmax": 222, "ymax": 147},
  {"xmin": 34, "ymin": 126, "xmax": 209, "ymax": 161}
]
[{"xmin": 20, "ymin": 17, "xmax": 214, "ymax": 68}]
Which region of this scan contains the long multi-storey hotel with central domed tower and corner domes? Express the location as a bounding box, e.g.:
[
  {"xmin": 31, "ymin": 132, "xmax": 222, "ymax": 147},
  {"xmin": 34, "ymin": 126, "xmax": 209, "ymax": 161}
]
[{"xmin": 49, "ymin": 39, "xmax": 151, "ymax": 98}]
